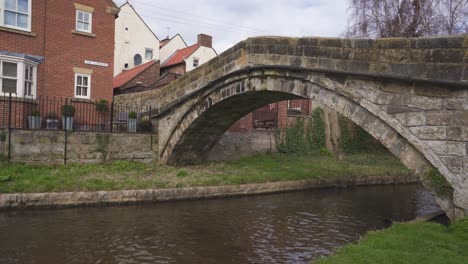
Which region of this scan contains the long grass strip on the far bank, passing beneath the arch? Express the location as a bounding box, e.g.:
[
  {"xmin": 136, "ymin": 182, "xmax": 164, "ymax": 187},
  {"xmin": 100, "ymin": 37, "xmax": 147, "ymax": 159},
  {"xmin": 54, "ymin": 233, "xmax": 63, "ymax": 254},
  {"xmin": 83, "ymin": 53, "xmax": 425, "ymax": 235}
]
[{"xmin": 0, "ymin": 153, "xmax": 410, "ymax": 193}]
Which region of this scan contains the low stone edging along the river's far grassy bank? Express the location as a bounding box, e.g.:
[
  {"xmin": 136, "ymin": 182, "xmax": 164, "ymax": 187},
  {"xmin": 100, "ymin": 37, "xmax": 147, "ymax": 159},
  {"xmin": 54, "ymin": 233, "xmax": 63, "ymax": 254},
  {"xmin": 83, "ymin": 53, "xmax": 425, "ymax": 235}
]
[{"xmin": 0, "ymin": 175, "xmax": 419, "ymax": 209}]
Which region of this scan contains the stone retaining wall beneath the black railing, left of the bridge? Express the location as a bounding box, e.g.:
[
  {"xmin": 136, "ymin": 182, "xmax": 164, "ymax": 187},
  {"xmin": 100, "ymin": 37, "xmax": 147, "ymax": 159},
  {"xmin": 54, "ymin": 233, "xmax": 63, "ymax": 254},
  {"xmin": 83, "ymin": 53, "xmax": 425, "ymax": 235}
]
[{"xmin": 0, "ymin": 130, "xmax": 158, "ymax": 164}]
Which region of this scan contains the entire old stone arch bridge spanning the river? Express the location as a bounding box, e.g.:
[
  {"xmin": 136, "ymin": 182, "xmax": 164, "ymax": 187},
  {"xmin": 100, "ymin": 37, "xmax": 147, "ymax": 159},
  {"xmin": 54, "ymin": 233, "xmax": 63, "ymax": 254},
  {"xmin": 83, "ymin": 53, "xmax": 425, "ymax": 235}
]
[{"xmin": 116, "ymin": 35, "xmax": 468, "ymax": 218}]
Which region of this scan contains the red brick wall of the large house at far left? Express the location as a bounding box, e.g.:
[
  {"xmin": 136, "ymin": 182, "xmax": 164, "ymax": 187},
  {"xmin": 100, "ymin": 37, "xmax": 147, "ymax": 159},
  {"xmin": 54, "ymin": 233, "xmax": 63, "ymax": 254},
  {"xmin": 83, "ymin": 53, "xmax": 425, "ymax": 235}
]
[{"xmin": 0, "ymin": 0, "xmax": 115, "ymax": 101}]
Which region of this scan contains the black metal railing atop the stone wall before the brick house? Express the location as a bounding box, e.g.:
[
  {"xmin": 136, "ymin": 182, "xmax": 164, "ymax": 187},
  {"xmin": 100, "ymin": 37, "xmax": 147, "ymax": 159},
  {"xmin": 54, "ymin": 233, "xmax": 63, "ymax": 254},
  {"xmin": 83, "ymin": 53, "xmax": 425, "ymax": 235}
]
[{"xmin": 0, "ymin": 94, "xmax": 157, "ymax": 133}]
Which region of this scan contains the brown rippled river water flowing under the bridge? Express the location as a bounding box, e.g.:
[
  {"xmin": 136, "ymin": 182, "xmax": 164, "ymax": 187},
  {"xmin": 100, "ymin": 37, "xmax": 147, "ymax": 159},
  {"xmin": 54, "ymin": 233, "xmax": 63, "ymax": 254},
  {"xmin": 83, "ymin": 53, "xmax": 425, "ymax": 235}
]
[{"xmin": 0, "ymin": 185, "xmax": 439, "ymax": 264}]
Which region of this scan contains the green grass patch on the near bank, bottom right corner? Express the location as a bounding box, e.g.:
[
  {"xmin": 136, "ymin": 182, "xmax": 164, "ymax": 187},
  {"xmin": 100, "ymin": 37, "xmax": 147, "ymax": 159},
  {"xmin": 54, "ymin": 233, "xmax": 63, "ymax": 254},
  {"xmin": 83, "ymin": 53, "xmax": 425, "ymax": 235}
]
[{"xmin": 315, "ymin": 218, "xmax": 468, "ymax": 264}]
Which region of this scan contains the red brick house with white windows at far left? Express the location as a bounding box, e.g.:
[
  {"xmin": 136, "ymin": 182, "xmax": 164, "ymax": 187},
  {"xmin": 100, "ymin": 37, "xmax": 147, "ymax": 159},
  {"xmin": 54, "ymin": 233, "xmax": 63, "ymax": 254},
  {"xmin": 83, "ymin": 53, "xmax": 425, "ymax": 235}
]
[{"xmin": 0, "ymin": 0, "xmax": 119, "ymax": 128}]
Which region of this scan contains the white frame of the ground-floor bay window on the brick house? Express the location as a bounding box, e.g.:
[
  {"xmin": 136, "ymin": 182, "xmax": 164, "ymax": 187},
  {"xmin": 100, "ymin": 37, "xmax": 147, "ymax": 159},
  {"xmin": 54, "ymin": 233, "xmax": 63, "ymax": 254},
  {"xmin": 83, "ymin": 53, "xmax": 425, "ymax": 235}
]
[{"xmin": 0, "ymin": 55, "xmax": 38, "ymax": 99}]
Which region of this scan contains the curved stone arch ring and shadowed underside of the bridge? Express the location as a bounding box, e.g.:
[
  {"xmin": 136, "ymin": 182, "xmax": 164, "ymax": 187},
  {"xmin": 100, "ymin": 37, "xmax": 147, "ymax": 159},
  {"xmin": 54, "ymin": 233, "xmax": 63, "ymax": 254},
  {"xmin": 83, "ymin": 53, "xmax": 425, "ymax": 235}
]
[{"xmin": 161, "ymin": 72, "xmax": 464, "ymax": 219}]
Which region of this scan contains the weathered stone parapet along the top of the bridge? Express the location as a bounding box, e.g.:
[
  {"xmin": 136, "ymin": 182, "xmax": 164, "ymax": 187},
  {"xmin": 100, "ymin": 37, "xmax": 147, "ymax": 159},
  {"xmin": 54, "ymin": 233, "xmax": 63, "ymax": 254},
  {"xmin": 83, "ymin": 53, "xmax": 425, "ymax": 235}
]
[{"xmin": 115, "ymin": 35, "xmax": 468, "ymax": 106}]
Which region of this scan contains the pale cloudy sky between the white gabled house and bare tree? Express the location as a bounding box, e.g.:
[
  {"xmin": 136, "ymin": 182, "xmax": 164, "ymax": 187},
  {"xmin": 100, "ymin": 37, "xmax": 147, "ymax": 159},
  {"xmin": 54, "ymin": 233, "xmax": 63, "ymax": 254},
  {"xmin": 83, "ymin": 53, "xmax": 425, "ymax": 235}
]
[{"xmin": 114, "ymin": 0, "xmax": 348, "ymax": 53}]
